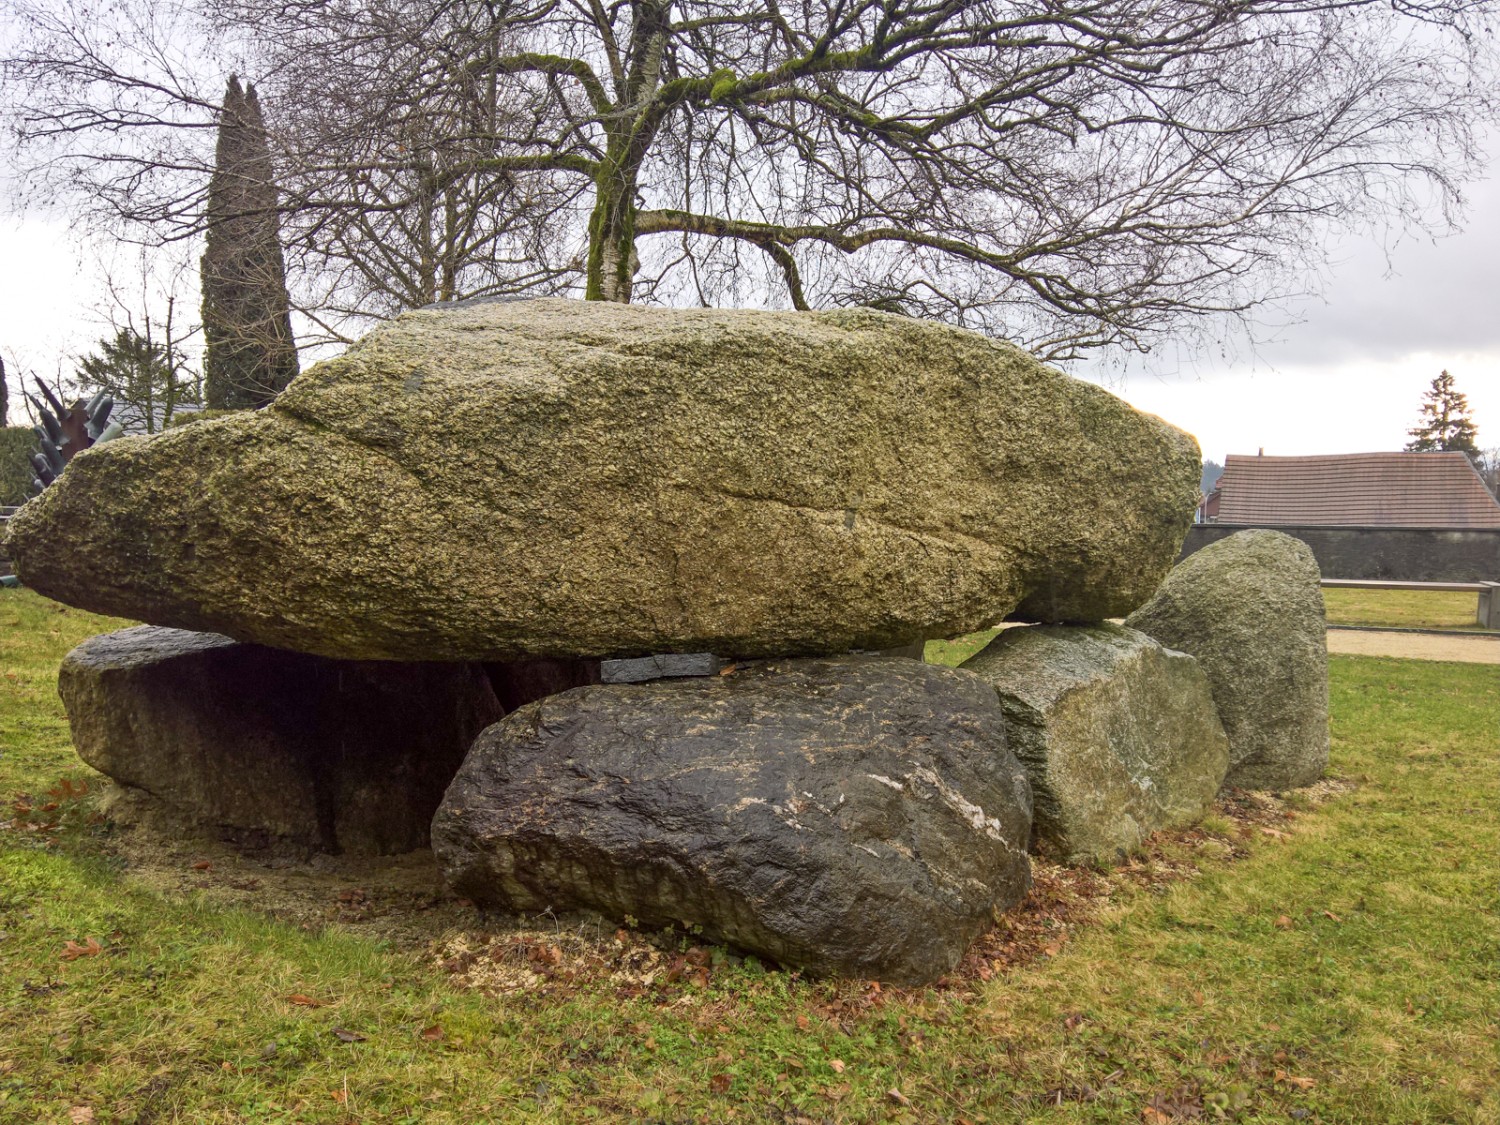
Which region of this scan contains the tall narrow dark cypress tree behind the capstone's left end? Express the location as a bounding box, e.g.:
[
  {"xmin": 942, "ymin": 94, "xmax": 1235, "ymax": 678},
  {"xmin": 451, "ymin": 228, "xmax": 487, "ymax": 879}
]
[{"xmin": 201, "ymin": 77, "xmax": 297, "ymax": 410}]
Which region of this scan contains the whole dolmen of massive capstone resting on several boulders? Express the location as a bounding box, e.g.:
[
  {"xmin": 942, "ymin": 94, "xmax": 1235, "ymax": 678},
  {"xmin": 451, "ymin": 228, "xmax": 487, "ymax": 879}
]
[{"xmin": 8, "ymin": 299, "xmax": 1328, "ymax": 983}]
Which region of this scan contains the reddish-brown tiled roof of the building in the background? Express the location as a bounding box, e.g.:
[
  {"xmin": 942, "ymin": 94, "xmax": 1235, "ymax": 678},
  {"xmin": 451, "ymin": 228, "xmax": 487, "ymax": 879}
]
[{"xmin": 1218, "ymin": 453, "xmax": 1500, "ymax": 528}]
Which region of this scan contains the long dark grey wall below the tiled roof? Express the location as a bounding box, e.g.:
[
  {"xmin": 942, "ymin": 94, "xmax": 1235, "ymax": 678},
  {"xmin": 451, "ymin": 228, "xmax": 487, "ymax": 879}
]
[{"xmin": 1182, "ymin": 524, "xmax": 1500, "ymax": 582}]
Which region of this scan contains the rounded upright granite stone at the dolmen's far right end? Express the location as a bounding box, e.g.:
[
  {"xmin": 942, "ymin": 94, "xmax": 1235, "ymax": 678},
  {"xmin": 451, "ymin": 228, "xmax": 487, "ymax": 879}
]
[{"xmin": 1127, "ymin": 531, "xmax": 1328, "ymax": 789}]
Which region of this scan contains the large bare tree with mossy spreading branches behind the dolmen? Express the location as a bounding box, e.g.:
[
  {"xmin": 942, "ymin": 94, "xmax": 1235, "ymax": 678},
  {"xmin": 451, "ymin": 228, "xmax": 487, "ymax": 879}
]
[{"xmin": 8, "ymin": 0, "xmax": 1494, "ymax": 359}]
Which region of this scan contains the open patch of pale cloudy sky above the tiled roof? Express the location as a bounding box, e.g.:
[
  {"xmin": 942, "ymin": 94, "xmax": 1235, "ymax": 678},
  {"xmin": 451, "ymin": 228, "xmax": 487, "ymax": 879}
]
[{"xmin": 1076, "ymin": 156, "xmax": 1500, "ymax": 462}]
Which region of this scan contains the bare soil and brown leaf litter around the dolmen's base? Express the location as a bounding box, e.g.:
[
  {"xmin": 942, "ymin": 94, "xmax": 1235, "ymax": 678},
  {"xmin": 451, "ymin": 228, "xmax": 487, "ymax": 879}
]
[{"xmin": 93, "ymin": 779, "xmax": 1355, "ymax": 1019}]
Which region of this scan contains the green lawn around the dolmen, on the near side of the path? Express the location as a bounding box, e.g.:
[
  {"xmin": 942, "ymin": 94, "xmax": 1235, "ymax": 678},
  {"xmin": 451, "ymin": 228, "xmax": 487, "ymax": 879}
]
[{"xmin": 0, "ymin": 591, "xmax": 1500, "ymax": 1125}]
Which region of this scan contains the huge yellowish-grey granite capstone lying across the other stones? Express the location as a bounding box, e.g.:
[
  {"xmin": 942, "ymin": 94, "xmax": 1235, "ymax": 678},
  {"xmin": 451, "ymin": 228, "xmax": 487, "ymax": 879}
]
[{"xmin": 9, "ymin": 299, "xmax": 1200, "ymax": 660}]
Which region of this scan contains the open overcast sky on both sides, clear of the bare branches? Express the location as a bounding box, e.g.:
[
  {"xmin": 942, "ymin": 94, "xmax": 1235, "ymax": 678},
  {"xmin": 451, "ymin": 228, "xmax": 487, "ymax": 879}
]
[{"xmin": 0, "ymin": 154, "xmax": 1500, "ymax": 461}]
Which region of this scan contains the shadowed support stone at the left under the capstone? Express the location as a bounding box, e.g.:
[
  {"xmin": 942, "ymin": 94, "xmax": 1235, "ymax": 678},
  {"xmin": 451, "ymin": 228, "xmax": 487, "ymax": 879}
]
[{"xmin": 59, "ymin": 626, "xmax": 503, "ymax": 854}]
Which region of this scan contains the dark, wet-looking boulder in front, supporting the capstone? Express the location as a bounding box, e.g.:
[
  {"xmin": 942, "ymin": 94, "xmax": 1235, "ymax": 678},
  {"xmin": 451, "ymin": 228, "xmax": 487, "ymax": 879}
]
[{"xmin": 432, "ymin": 657, "xmax": 1031, "ymax": 983}]
